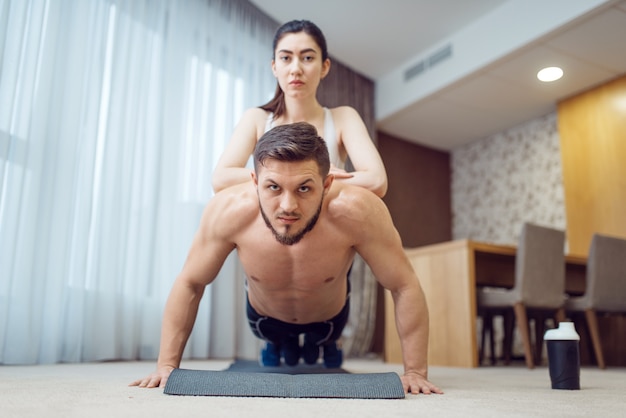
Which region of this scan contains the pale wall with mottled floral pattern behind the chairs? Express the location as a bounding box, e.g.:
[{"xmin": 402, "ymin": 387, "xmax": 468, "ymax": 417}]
[{"xmin": 451, "ymin": 113, "xmax": 566, "ymax": 245}]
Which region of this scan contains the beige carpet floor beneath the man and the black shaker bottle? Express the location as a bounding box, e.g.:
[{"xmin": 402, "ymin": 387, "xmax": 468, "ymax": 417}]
[{"xmin": 0, "ymin": 360, "xmax": 626, "ymax": 418}]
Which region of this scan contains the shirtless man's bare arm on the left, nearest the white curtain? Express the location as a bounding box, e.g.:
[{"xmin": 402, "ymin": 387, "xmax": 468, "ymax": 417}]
[{"xmin": 130, "ymin": 191, "xmax": 241, "ymax": 388}]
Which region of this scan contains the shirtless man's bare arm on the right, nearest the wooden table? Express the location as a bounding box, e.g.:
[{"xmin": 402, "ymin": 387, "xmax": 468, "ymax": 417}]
[{"xmin": 346, "ymin": 188, "xmax": 443, "ymax": 394}]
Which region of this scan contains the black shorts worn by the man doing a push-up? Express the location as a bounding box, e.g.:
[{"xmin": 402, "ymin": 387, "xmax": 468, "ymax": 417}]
[{"xmin": 246, "ymin": 282, "xmax": 350, "ymax": 346}]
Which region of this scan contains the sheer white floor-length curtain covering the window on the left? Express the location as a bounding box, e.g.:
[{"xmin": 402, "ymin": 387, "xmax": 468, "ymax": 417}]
[{"xmin": 0, "ymin": 0, "xmax": 276, "ymax": 364}]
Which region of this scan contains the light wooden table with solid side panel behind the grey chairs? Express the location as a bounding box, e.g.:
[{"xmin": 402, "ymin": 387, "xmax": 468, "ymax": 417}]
[{"xmin": 385, "ymin": 240, "xmax": 586, "ymax": 367}]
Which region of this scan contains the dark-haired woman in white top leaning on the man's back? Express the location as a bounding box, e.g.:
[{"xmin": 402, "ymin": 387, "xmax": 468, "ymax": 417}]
[{"xmin": 212, "ymin": 20, "xmax": 387, "ymax": 197}]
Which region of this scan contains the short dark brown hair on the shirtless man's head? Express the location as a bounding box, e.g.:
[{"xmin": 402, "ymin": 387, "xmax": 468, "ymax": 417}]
[{"xmin": 254, "ymin": 122, "xmax": 330, "ymax": 178}]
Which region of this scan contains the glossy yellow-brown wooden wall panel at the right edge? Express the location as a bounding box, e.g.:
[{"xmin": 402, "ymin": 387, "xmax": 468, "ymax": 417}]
[{"xmin": 558, "ymin": 76, "xmax": 626, "ymax": 254}]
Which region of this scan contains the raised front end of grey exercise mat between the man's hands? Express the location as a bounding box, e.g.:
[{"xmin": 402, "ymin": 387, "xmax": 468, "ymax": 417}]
[{"xmin": 163, "ymin": 366, "xmax": 404, "ymax": 399}]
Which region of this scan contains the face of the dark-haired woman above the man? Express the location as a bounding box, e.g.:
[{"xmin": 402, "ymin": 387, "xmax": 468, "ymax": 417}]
[{"xmin": 272, "ymin": 32, "xmax": 330, "ymax": 98}]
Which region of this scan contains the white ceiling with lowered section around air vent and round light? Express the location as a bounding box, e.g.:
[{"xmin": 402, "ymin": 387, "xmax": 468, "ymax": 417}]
[{"xmin": 250, "ymin": 0, "xmax": 626, "ymax": 150}]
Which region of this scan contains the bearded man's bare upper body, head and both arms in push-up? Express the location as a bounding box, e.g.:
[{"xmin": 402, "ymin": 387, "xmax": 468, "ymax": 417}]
[{"xmin": 131, "ymin": 122, "xmax": 442, "ymax": 394}]
